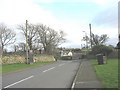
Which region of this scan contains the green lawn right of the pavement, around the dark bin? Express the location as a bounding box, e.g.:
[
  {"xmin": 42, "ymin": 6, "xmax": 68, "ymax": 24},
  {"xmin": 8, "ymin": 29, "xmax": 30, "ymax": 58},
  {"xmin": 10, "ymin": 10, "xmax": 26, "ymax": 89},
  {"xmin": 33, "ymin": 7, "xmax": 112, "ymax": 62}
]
[{"xmin": 92, "ymin": 59, "xmax": 120, "ymax": 88}]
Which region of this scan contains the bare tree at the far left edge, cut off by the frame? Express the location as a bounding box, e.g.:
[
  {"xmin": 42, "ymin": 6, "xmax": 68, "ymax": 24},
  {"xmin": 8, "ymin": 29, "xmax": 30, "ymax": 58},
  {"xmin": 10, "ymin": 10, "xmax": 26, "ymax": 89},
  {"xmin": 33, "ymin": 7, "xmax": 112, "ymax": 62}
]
[{"xmin": 0, "ymin": 24, "xmax": 16, "ymax": 51}]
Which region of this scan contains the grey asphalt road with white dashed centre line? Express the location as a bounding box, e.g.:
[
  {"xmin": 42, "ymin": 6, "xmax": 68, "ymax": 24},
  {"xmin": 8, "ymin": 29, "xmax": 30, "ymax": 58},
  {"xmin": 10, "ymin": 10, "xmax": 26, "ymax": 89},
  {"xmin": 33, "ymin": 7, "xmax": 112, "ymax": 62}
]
[{"xmin": 2, "ymin": 60, "xmax": 80, "ymax": 88}]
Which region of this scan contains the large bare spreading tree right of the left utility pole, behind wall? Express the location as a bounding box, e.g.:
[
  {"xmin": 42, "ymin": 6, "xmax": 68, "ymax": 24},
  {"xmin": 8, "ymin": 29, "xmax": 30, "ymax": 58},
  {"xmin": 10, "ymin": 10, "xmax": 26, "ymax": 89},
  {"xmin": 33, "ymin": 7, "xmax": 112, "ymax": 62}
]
[{"xmin": 36, "ymin": 24, "xmax": 65, "ymax": 54}]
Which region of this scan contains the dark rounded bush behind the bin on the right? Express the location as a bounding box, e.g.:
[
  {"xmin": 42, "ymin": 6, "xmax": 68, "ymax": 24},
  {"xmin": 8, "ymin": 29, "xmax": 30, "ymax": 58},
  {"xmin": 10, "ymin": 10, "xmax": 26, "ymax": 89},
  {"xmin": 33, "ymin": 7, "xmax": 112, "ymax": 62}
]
[{"xmin": 92, "ymin": 45, "xmax": 113, "ymax": 56}]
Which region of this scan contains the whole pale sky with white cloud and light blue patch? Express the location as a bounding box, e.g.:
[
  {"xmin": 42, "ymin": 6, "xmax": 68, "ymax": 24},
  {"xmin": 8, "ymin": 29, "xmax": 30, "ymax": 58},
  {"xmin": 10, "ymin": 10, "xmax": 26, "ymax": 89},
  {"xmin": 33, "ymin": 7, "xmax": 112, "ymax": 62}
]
[{"xmin": 0, "ymin": 0, "xmax": 119, "ymax": 48}]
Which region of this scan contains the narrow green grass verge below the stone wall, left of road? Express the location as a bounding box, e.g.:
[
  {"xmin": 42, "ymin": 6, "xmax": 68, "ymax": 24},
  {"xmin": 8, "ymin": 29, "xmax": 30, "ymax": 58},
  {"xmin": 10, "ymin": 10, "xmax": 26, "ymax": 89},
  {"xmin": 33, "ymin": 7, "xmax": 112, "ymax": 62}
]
[{"xmin": 2, "ymin": 61, "xmax": 53, "ymax": 74}]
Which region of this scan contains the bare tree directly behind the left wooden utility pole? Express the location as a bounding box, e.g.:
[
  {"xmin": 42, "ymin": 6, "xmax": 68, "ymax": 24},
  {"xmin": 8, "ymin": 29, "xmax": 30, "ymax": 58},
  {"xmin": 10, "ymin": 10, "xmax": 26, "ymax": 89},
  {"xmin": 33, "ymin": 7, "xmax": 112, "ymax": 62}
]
[{"xmin": 18, "ymin": 24, "xmax": 38, "ymax": 50}]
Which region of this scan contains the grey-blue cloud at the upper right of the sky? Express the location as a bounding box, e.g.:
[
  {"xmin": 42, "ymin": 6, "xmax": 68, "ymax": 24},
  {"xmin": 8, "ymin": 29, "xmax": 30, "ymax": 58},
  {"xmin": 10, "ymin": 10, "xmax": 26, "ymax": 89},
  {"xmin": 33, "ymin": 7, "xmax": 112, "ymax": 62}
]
[{"xmin": 93, "ymin": 6, "xmax": 118, "ymax": 28}]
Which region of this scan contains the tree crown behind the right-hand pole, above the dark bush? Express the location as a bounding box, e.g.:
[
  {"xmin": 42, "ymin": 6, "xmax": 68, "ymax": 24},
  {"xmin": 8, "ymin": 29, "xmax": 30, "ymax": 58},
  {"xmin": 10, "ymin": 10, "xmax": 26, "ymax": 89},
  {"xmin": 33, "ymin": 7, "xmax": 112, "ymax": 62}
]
[{"xmin": 82, "ymin": 33, "xmax": 109, "ymax": 46}]
